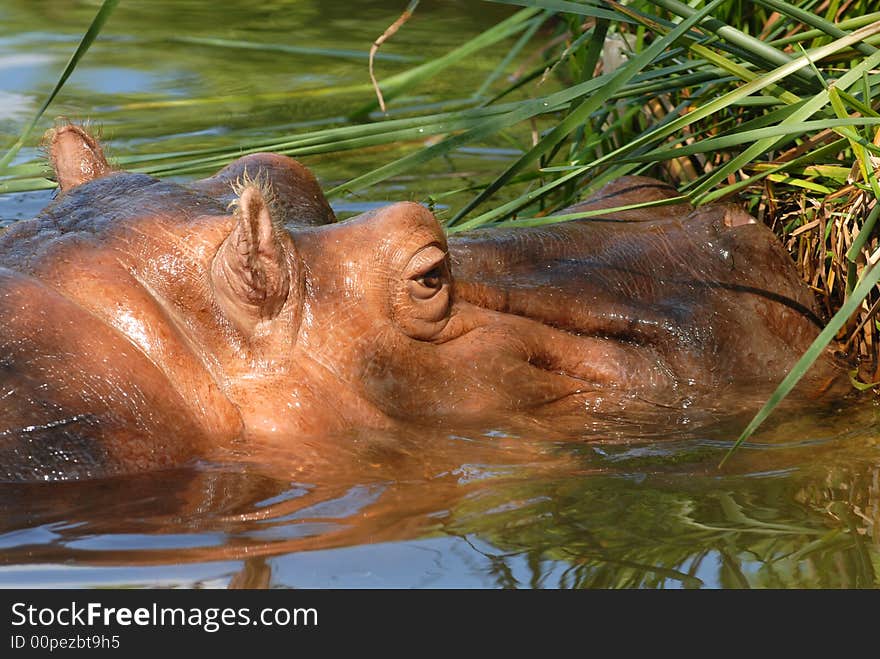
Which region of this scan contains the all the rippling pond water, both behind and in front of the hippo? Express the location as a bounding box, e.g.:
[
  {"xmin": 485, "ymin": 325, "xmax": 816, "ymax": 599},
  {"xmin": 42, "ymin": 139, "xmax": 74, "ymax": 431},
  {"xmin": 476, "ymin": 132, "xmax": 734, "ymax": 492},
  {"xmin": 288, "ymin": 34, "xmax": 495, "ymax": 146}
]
[{"xmin": 0, "ymin": 0, "xmax": 880, "ymax": 588}]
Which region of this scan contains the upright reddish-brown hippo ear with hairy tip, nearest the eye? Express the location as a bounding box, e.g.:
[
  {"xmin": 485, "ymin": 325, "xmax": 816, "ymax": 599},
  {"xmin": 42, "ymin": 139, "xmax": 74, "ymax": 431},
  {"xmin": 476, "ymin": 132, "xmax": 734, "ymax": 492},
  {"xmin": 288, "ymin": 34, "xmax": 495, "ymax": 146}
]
[{"xmin": 211, "ymin": 184, "xmax": 291, "ymax": 332}]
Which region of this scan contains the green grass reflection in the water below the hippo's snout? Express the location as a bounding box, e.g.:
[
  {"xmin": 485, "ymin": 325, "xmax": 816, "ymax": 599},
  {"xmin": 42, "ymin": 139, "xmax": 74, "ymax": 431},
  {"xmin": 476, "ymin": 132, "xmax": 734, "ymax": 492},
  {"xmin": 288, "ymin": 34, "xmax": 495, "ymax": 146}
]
[{"xmin": 446, "ymin": 462, "xmax": 880, "ymax": 588}]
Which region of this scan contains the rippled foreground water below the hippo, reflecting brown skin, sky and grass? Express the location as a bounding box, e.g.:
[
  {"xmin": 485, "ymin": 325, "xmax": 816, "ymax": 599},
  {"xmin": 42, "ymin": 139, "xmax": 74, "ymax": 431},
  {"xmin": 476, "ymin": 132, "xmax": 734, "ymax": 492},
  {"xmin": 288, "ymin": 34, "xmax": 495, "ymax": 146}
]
[{"xmin": 0, "ymin": 403, "xmax": 880, "ymax": 588}]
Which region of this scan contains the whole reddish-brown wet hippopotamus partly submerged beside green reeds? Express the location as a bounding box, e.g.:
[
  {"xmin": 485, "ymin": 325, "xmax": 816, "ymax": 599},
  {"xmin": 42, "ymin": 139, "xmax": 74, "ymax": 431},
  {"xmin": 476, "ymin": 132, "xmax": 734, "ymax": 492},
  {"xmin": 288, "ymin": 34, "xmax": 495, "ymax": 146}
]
[{"xmin": 0, "ymin": 124, "xmax": 838, "ymax": 480}]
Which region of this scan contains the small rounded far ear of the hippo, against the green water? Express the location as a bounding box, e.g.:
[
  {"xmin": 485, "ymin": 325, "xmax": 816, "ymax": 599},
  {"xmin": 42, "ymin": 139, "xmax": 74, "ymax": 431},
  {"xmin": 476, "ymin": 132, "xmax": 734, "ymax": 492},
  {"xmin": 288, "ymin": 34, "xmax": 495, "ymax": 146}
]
[{"xmin": 44, "ymin": 124, "xmax": 110, "ymax": 192}]
